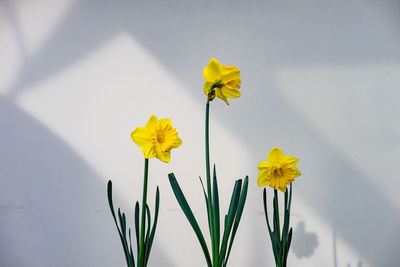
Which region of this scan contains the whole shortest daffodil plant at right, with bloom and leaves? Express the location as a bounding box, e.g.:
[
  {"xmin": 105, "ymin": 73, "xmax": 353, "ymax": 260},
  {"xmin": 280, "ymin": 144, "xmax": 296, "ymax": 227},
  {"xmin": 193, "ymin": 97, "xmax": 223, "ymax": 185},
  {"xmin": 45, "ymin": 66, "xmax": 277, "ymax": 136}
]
[{"xmin": 257, "ymin": 147, "xmax": 301, "ymax": 267}]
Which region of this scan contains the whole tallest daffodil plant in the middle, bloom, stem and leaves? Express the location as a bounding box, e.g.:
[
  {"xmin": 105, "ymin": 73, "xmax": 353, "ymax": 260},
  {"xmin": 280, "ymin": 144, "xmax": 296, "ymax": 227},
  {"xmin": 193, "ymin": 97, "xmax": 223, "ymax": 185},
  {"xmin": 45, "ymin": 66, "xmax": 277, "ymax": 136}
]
[{"xmin": 168, "ymin": 59, "xmax": 248, "ymax": 267}]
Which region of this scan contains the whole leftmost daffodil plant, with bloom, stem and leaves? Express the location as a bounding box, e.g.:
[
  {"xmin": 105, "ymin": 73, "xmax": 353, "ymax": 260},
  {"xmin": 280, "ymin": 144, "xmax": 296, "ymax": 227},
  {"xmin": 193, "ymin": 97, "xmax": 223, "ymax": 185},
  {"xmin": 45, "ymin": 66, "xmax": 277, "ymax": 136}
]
[{"xmin": 107, "ymin": 115, "xmax": 182, "ymax": 267}]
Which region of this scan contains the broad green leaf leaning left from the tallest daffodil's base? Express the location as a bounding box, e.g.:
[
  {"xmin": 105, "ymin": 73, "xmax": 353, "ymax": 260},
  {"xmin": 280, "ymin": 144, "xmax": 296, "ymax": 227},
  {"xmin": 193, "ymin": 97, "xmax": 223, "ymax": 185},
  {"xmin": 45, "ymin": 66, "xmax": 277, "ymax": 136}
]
[{"xmin": 168, "ymin": 173, "xmax": 212, "ymax": 267}]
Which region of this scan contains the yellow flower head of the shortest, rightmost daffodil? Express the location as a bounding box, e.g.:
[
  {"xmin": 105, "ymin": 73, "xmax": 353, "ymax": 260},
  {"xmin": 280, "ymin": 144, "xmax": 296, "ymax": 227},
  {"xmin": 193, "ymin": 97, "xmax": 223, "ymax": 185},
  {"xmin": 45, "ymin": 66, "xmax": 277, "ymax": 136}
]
[{"xmin": 257, "ymin": 147, "xmax": 301, "ymax": 192}]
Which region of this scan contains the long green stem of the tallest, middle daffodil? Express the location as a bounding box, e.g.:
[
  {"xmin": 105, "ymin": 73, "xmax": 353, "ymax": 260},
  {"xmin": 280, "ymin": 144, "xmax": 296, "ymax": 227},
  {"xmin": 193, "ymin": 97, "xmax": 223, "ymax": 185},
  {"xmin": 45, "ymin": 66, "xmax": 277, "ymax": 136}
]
[{"xmin": 205, "ymin": 101, "xmax": 219, "ymax": 267}]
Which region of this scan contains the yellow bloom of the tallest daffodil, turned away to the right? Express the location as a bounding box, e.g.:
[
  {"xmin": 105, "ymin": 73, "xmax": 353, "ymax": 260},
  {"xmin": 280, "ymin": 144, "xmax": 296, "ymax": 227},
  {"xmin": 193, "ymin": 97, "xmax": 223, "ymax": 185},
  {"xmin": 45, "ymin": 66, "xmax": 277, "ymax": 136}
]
[{"xmin": 203, "ymin": 58, "xmax": 242, "ymax": 105}]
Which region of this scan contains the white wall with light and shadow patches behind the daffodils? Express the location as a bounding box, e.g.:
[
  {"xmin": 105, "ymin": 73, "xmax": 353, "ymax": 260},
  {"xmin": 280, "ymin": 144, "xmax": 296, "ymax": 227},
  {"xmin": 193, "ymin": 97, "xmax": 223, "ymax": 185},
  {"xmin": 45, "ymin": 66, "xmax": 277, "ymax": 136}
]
[{"xmin": 0, "ymin": 0, "xmax": 400, "ymax": 267}]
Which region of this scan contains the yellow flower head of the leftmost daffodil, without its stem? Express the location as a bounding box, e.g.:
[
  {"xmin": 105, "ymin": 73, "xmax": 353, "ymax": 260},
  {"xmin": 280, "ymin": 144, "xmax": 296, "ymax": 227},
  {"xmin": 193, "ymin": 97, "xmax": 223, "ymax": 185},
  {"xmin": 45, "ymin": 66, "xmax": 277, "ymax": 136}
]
[{"xmin": 131, "ymin": 115, "xmax": 182, "ymax": 162}]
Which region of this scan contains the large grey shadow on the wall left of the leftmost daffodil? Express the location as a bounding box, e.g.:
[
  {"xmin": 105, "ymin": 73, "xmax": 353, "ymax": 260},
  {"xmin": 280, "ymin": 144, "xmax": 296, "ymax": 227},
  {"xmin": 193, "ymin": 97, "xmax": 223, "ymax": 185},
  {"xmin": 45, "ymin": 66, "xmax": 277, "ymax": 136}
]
[{"xmin": 0, "ymin": 98, "xmax": 173, "ymax": 267}]
